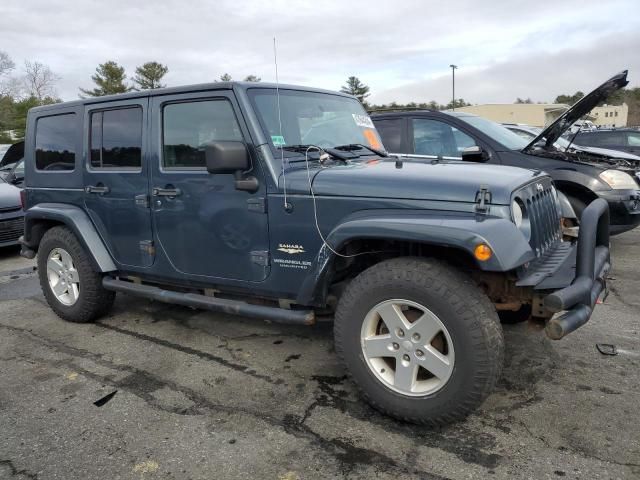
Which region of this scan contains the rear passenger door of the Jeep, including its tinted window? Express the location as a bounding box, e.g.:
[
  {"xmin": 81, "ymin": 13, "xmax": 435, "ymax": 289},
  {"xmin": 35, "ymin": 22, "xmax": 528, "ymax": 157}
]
[{"xmin": 84, "ymin": 98, "xmax": 153, "ymax": 269}]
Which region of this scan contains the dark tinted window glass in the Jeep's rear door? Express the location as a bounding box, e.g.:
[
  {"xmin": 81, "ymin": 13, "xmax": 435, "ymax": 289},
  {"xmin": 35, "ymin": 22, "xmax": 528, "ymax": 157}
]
[{"xmin": 90, "ymin": 107, "xmax": 142, "ymax": 170}]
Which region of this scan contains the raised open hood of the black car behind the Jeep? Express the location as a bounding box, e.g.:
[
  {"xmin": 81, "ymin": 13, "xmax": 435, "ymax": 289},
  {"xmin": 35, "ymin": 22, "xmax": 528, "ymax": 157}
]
[{"xmin": 522, "ymin": 70, "xmax": 629, "ymax": 153}]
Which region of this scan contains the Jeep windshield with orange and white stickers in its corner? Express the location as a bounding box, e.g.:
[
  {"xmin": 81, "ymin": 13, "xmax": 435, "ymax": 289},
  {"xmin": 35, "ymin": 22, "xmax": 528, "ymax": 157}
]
[{"xmin": 248, "ymin": 88, "xmax": 384, "ymax": 155}]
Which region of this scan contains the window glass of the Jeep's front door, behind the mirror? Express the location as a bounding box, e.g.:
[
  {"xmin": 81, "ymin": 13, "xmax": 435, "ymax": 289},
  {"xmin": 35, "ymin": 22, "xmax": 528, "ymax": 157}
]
[{"xmin": 162, "ymin": 100, "xmax": 243, "ymax": 169}]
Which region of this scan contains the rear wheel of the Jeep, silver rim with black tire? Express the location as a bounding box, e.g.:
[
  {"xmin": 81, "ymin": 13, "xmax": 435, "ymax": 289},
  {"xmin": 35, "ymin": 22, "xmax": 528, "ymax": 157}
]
[{"xmin": 38, "ymin": 227, "xmax": 115, "ymax": 323}]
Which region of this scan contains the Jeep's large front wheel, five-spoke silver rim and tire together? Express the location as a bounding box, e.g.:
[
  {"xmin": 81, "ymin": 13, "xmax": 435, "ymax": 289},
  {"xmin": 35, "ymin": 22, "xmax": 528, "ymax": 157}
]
[{"xmin": 334, "ymin": 258, "xmax": 504, "ymax": 425}]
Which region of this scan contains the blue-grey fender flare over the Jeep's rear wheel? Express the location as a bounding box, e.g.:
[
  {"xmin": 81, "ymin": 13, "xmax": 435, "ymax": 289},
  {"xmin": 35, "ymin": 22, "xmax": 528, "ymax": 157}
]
[{"xmin": 22, "ymin": 203, "xmax": 117, "ymax": 272}]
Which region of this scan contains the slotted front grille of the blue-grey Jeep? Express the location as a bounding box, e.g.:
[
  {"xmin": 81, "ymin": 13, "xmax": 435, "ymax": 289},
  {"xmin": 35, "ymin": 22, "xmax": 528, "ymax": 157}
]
[{"xmin": 516, "ymin": 178, "xmax": 562, "ymax": 257}]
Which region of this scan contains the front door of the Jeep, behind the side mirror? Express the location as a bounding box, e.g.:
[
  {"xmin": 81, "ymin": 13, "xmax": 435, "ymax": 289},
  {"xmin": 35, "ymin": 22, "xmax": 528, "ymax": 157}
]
[{"xmin": 151, "ymin": 91, "xmax": 269, "ymax": 281}]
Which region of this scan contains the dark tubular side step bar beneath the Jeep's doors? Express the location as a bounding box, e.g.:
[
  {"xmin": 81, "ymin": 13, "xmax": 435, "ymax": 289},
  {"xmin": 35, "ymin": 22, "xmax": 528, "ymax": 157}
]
[{"xmin": 102, "ymin": 277, "xmax": 316, "ymax": 325}]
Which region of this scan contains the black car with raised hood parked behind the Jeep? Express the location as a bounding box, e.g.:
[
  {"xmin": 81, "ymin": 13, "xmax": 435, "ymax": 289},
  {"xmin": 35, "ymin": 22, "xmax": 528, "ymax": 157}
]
[{"xmin": 371, "ymin": 71, "xmax": 640, "ymax": 234}]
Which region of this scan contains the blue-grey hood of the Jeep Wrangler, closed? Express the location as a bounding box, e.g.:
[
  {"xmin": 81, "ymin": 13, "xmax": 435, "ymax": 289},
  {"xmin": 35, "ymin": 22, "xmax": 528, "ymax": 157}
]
[{"xmin": 300, "ymin": 159, "xmax": 540, "ymax": 205}]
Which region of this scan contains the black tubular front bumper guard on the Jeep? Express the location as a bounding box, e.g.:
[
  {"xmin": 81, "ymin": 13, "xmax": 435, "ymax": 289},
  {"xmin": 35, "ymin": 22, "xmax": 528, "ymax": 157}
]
[{"xmin": 544, "ymin": 199, "xmax": 611, "ymax": 340}]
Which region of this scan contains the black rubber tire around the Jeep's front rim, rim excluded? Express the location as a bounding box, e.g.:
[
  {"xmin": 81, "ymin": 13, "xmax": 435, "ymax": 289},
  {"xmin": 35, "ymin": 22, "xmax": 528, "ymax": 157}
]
[{"xmin": 334, "ymin": 257, "xmax": 504, "ymax": 426}]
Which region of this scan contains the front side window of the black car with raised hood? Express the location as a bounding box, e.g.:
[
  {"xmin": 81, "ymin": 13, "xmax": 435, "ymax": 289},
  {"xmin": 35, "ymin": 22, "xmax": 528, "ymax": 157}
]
[{"xmin": 412, "ymin": 118, "xmax": 476, "ymax": 158}]
